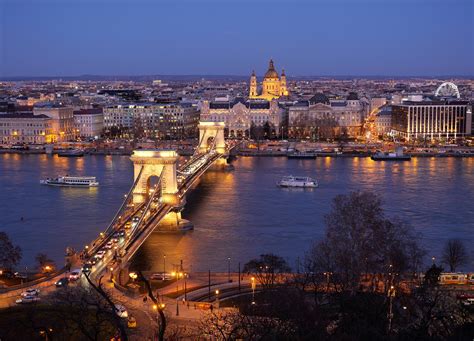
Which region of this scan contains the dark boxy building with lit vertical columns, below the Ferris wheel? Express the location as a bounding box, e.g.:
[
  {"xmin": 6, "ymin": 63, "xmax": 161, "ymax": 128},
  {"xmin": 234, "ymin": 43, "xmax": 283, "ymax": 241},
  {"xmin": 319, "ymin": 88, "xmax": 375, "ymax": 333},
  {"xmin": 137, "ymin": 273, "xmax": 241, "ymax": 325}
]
[{"xmin": 392, "ymin": 100, "xmax": 472, "ymax": 141}]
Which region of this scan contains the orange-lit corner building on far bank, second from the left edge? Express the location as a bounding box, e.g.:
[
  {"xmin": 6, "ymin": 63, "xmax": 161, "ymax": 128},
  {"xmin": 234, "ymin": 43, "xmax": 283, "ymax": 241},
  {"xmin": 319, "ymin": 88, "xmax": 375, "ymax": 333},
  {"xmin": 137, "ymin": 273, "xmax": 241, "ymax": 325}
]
[{"xmin": 33, "ymin": 103, "xmax": 76, "ymax": 142}]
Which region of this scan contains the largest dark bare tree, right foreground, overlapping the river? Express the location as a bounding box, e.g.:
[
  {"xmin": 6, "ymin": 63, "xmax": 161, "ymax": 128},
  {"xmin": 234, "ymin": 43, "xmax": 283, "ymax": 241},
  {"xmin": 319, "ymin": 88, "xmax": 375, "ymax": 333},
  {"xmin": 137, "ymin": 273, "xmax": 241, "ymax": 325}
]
[{"xmin": 306, "ymin": 191, "xmax": 424, "ymax": 293}]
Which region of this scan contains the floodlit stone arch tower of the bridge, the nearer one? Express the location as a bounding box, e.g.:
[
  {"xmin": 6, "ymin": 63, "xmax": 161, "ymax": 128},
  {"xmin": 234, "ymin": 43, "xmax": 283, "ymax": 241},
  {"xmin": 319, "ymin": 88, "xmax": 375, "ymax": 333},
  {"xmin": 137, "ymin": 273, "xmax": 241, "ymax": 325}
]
[{"xmin": 130, "ymin": 149, "xmax": 180, "ymax": 205}]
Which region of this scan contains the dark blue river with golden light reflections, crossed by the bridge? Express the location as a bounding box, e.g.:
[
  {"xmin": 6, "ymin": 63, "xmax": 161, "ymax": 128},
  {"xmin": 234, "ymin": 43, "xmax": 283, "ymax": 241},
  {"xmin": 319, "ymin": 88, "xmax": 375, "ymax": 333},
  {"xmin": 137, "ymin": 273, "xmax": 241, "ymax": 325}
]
[{"xmin": 0, "ymin": 154, "xmax": 474, "ymax": 271}]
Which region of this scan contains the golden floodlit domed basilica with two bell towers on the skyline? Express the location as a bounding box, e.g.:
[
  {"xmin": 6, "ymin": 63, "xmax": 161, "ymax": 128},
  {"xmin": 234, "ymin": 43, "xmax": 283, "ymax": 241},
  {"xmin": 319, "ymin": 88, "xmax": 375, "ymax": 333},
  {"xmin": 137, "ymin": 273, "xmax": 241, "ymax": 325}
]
[{"xmin": 249, "ymin": 59, "xmax": 288, "ymax": 101}]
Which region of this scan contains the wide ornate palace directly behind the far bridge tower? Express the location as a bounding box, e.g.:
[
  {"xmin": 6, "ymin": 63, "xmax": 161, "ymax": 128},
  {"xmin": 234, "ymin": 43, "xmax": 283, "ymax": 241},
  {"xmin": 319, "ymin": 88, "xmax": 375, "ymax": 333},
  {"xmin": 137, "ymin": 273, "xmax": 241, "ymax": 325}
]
[{"xmin": 201, "ymin": 98, "xmax": 284, "ymax": 137}]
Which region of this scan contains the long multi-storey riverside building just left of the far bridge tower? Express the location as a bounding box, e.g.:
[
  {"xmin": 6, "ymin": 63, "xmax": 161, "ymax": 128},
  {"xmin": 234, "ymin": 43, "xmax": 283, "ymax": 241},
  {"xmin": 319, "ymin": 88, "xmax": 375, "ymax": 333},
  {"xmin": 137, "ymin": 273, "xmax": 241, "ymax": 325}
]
[{"xmin": 104, "ymin": 102, "xmax": 199, "ymax": 139}]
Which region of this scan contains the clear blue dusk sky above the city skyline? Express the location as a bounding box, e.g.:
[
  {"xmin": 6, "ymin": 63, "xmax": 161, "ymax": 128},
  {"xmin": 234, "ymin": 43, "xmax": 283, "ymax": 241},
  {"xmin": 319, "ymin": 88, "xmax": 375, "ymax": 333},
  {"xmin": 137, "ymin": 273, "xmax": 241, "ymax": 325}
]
[{"xmin": 0, "ymin": 0, "xmax": 474, "ymax": 77}]
